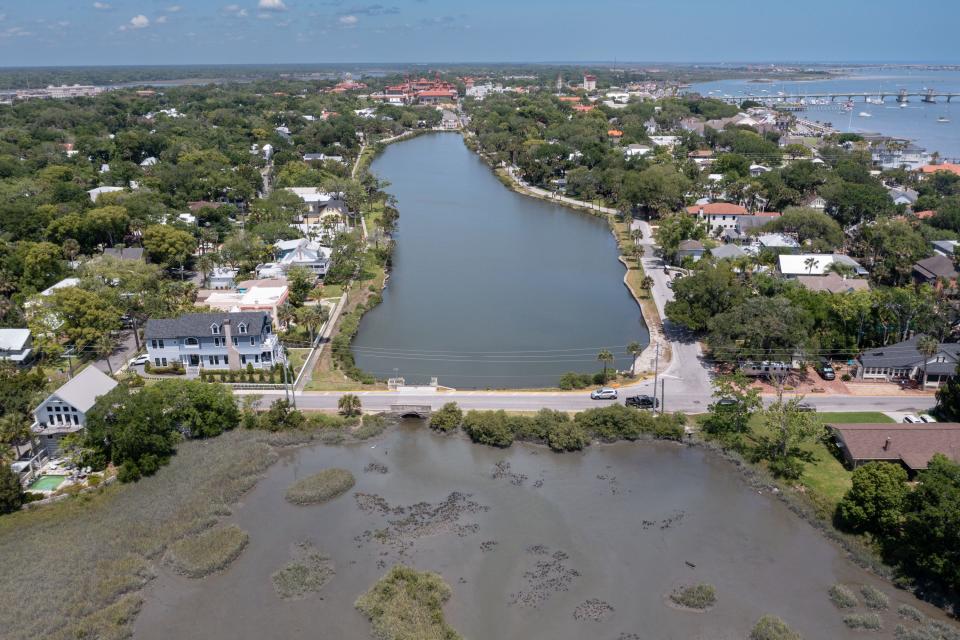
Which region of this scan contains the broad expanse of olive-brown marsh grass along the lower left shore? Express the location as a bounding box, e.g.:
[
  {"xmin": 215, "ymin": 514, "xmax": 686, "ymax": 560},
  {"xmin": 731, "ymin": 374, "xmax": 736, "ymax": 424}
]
[{"xmin": 0, "ymin": 430, "xmax": 276, "ymax": 640}]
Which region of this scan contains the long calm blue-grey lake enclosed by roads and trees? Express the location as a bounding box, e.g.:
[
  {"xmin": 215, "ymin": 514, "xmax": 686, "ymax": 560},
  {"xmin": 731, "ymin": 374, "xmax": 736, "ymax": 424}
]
[{"xmin": 353, "ymin": 133, "xmax": 649, "ymax": 388}]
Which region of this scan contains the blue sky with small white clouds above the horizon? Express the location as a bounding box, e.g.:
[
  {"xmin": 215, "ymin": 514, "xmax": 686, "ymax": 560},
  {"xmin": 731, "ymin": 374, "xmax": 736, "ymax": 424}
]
[{"xmin": 0, "ymin": 0, "xmax": 960, "ymax": 66}]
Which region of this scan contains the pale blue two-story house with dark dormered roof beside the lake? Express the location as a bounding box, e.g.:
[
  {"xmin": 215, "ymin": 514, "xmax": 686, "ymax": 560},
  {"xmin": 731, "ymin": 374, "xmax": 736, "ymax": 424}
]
[{"xmin": 143, "ymin": 311, "xmax": 285, "ymax": 371}]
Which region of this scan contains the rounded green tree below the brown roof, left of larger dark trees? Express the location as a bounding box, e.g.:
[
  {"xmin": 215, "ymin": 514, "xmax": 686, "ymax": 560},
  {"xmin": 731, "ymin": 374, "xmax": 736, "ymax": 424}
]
[{"xmin": 836, "ymin": 462, "xmax": 909, "ymax": 536}]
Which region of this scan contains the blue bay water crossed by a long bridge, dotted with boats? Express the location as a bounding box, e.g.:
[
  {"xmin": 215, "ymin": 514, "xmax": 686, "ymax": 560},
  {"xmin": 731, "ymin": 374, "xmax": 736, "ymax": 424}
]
[{"xmin": 691, "ymin": 68, "xmax": 960, "ymax": 159}]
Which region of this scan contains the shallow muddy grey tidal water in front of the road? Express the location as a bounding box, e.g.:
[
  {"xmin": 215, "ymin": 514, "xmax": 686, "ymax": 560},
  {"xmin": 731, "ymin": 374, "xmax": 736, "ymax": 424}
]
[{"xmin": 135, "ymin": 420, "xmax": 956, "ymax": 640}]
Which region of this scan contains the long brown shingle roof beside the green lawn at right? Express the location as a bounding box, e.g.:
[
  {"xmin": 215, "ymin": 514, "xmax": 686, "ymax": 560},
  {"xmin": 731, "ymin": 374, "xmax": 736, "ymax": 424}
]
[{"xmin": 828, "ymin": 422, "xmax": 960, "ymax": 470}]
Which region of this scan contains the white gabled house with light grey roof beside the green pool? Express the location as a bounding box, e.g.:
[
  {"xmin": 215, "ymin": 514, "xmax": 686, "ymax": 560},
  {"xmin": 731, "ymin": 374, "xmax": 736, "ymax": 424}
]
[{"xmin": 33, "ymin": 366, "xmax": 117, "ymax": 457}]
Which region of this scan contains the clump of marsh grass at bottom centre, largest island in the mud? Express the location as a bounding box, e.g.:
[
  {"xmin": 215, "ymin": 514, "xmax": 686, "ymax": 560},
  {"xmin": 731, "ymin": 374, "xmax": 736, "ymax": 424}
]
[{"xmin": 355, "ymin": 565, "xmax": 462, "ymax": 640}]
